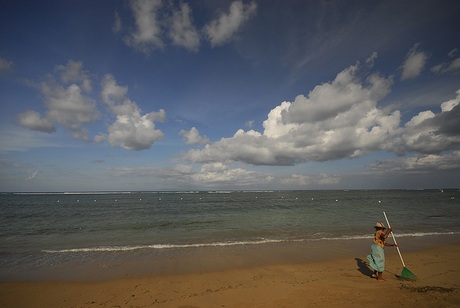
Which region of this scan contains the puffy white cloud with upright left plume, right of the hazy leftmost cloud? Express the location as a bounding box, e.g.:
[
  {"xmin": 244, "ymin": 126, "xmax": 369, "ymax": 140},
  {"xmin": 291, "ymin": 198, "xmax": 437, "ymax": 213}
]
[{"xmin": 97, "ymin": 75, "xmax": 166, "ymax": 150}]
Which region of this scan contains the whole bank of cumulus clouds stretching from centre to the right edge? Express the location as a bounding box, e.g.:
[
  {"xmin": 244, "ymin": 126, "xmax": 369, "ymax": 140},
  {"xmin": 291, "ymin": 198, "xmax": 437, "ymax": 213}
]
[{"xmin": 184, "ymin": 55, "xmax": 460, "ymax": 165}]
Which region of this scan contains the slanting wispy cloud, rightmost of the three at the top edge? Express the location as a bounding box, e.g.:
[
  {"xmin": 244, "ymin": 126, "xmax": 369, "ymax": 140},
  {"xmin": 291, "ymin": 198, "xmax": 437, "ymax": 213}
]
[{"xmin": 203, "ymin": 1, "xmax": 257, "ymax": 46}]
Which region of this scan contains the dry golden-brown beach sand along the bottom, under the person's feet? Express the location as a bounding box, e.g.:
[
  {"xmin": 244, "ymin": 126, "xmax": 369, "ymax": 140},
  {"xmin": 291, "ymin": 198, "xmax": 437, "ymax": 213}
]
[{"xmin": 0, "ymin": 241, "xmax": 460, "ymax": 307}]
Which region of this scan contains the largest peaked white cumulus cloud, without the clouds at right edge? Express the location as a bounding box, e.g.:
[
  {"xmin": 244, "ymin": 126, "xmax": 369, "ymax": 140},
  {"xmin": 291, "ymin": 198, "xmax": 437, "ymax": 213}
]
[{"xmin": 184, "ymin": 60, "xmax": 400, "ymax": 165}]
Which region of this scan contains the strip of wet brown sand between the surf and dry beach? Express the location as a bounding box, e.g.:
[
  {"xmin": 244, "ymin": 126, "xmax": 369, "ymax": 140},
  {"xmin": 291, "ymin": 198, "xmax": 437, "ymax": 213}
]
[{"xmin": 0, "ymin": 234, "xmax": 460, "ymax": 282}]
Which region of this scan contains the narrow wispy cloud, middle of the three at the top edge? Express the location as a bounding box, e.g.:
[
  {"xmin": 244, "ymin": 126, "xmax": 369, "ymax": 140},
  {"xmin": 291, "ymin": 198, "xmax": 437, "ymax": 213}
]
[{"xmin": 169, "ymin": 3, "xmax": 200, "ymax": 51}]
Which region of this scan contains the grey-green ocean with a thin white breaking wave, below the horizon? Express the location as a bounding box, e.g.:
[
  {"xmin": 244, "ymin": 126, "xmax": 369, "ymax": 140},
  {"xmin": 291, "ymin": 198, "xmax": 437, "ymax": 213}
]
[{"xmin": 0, "ymin": 190, "xmax": 460, "ymax": 280}]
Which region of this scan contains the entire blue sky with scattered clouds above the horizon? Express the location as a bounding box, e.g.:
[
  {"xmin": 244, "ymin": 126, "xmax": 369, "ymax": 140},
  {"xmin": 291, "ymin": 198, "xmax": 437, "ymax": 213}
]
[{"xmin": 0, "ymin": 0, "xmax": 460, "ymax": 192}]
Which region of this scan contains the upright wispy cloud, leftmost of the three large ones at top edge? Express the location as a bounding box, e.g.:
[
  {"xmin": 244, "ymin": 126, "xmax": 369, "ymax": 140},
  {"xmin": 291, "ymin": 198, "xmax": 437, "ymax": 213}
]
[{"xmin": 125, "ymin": 0, "xmax": 163, "ymax": 53}]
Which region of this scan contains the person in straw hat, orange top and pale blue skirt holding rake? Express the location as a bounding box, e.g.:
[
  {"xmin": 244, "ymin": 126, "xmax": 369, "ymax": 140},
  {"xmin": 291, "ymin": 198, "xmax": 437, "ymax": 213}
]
[{"xmin": 367, "ymin": 222, "xmax": 396, "ymax": 281}]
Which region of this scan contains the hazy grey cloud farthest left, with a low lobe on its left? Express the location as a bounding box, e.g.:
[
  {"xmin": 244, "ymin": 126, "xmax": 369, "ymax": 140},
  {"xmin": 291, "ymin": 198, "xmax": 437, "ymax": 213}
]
[{"xmin": 18, "ymin": 60, "xmax": 99, "ymax": 141}]
